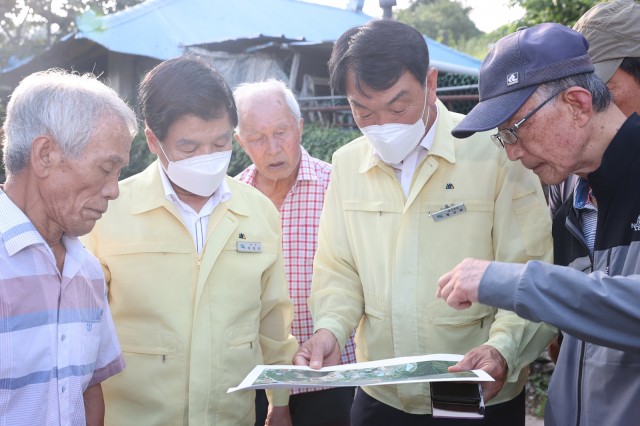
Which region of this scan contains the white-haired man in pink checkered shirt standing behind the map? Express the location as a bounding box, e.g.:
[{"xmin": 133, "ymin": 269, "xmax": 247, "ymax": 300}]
[{"xmin": 234, "ymin": 80, "xmax": 356, "ymax": 426}]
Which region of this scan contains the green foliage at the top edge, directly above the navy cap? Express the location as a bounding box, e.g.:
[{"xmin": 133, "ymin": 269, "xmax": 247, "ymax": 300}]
[{"xmin": 510, "ymin": 0, "xmax": 601, "ymax": 26}]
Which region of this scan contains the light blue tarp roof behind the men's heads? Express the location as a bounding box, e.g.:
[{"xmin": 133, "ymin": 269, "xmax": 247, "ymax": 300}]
[{"xmin": 70, "ymin": 0, "xmax": 480, "ymax": 74}]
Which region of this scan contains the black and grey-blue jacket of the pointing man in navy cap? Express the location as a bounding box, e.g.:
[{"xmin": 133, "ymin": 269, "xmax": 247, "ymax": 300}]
[{"xmin": 479, "ymin": 114, "xmax": 640, "ymax": 426}]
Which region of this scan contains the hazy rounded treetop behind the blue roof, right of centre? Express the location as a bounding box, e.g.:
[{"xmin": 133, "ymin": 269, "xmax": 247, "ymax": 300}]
[{"xmin": 397, "ymin": 0, "xmax": 482, "ymax": 47}]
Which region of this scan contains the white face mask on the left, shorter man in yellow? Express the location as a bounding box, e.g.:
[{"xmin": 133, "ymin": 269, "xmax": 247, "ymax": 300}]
[{"xmin": 158, "ymin": 142, "xmax": 231, "ymax": 197}]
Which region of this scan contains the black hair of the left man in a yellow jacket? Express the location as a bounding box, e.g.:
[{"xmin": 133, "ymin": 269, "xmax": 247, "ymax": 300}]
[{"xmin": 138, "ymin": 56, "xmax": 238, "ymax": 141}]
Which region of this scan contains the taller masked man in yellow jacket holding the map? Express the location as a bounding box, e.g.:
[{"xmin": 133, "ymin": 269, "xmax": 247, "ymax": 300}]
[{"xmin": 294, "ymin": 20, "xmax": 554, "ymax": 426}]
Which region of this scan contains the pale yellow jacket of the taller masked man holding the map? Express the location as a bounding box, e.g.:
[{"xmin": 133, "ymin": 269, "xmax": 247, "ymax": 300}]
[{"xmin": 309, "ymin": 102, "xmax": 555, "ymax": 414}]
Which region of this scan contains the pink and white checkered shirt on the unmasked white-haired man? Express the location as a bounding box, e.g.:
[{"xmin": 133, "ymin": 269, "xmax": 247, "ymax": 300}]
[{"xmin": 236, "ymin": 148, "xmax": 356, "ymax": 394}]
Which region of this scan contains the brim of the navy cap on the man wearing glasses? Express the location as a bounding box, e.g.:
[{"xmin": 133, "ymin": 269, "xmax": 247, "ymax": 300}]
[{"xmin": 451, "ymin": 86, "xmax": 538, "ymax": 139}]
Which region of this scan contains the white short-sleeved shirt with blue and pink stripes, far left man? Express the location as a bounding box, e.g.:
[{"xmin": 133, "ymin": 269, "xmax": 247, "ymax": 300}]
[{"xmin": 0, "ymin": 190, "xmax": 124, "ymax": 426}]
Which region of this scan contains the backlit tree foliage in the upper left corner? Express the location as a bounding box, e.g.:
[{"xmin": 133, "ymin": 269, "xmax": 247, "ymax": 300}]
[{"xmin": 0, "ymin": 0, "xmax": 142, "ymax": 67}]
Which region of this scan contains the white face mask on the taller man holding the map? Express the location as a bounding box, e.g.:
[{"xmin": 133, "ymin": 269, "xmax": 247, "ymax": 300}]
[{"xmin": 360, "ymin": 90, "xmax": 431, "ymax": 164}]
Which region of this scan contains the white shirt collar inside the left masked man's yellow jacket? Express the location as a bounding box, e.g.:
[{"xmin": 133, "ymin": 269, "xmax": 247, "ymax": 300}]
[{"xmin": 158, "ymin": 161, "xmax": 231, "ymax": 255}]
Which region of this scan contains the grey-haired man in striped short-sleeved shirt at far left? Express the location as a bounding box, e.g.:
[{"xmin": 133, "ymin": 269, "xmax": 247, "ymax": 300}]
[{"xmin": 0, "ymin": 70, "xmax": 137, "ymax": 426}]
